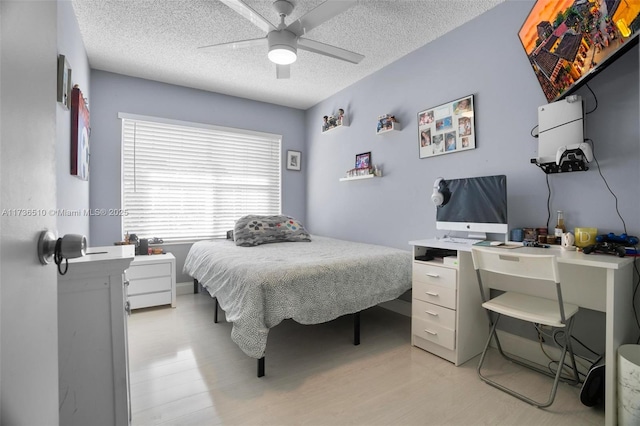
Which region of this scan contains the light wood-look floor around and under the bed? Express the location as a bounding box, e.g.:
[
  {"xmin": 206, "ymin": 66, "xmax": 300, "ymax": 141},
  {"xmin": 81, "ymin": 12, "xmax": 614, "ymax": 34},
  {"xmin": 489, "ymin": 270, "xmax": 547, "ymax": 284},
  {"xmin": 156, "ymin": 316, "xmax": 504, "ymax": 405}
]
[{"xmin": 129, "ymin": 293, "xmax": 604, "ymax": 426}]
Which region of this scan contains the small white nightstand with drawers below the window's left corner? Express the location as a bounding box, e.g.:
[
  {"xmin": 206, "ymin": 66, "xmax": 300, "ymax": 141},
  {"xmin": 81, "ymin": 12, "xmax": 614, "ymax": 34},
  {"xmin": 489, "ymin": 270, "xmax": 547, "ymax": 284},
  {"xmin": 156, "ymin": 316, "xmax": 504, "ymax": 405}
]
[{"xmin": 126, "ymin": 253, "xmax": 176, "ymax": 309}]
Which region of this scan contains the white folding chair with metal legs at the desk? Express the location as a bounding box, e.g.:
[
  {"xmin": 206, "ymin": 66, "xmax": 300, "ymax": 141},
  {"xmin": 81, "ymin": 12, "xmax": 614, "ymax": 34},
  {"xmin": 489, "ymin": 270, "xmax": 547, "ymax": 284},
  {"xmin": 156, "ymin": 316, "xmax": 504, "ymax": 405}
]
[{"xmin": 471, "ymin": 247, "xmax": 579, "ymax": 408}]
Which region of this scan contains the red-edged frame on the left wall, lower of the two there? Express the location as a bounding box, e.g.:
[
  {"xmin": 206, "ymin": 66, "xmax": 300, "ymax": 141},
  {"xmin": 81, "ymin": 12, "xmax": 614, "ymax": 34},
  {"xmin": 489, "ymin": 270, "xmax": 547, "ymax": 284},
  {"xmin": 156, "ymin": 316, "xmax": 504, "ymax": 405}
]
[{"xmin": 71, "ymin": 87, "xmax": 91, "ymax": 180}]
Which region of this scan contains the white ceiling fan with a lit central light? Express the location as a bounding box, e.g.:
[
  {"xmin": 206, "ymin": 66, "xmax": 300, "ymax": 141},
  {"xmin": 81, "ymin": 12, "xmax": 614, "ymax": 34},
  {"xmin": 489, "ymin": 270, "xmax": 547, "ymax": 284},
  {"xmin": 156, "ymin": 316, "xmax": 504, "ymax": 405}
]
[{"xmin": 199, "ymin": 0, "xmax": 364, "ymax": 78}]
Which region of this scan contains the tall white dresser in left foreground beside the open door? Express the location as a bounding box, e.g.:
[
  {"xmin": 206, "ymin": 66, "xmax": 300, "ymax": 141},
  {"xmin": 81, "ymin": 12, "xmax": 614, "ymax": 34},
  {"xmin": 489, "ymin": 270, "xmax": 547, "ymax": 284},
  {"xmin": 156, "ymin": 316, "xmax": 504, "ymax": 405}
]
[{"xmin": 57, "ymin": 246, "xmax": 134, "ymax": 426}]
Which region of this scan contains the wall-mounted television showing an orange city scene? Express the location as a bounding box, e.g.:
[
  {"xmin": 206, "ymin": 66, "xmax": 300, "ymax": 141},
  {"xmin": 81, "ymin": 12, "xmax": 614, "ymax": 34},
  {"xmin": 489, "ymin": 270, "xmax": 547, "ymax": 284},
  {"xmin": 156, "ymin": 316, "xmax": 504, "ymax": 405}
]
[{"xmin": 518, "ymin": 0, "xmax": 640, "ymax": 103}]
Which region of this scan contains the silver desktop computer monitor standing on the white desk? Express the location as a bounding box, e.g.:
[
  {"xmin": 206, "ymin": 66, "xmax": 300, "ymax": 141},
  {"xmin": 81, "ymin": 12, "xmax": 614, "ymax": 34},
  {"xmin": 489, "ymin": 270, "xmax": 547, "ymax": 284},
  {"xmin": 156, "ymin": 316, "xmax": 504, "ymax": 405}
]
[{"xmin": 436, "ymin": 175, "xmax": 509, "ymax": 240}]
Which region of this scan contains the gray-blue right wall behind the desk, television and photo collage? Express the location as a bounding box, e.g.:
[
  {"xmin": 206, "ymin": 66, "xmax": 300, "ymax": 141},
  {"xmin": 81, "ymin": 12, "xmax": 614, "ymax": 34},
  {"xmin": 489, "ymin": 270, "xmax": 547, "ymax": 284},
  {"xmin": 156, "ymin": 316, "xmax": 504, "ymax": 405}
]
[{"xmin": 306, "ymin": 1, "xmax": 640, "ymax": 249}]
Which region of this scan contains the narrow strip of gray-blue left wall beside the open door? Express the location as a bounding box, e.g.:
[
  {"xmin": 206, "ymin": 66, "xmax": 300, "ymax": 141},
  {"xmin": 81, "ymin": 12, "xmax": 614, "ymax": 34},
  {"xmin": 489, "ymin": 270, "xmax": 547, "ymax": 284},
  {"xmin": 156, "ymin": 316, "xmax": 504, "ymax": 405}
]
[{"xmin": 56, "ymin": 1, "xmax": 92, "ymax": 240}]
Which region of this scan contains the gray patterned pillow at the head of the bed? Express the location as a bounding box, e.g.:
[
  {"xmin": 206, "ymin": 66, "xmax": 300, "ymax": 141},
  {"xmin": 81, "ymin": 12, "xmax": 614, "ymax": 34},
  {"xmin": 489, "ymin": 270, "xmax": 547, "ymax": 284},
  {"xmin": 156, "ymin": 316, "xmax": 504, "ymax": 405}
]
[{"xmin": 233, "ymin": 215, "xmax": 311, "ymax": 247}]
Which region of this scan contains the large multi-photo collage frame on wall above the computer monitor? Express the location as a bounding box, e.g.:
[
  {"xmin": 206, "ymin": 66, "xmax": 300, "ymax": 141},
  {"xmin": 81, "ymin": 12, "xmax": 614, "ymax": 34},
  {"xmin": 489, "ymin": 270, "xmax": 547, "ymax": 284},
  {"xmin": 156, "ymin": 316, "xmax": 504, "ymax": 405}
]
[{"xmin": 418, "ymin": 95, "xmax": 476, "ymax": 158}]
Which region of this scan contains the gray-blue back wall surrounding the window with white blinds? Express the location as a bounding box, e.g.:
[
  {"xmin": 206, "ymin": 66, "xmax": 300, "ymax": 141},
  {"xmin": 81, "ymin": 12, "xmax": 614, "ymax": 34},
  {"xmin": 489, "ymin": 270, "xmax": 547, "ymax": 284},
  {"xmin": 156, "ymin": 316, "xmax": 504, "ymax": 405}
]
[{"xmin": 90, "ymin": 70, "xmax": 306, "ymax": 282}]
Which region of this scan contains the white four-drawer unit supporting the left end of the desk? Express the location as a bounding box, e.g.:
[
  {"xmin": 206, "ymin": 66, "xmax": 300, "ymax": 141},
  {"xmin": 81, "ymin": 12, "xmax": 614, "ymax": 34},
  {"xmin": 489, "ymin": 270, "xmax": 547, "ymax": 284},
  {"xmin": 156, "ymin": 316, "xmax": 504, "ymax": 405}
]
[{"xmin": 409, "ymin": 240, "xmax": 489, "ymax": 365}]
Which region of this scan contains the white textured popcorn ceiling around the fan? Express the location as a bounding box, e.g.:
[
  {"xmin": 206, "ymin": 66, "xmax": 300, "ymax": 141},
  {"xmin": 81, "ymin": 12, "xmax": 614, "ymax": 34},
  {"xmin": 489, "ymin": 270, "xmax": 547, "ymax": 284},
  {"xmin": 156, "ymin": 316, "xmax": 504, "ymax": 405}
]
[{"xmin": 73, "ymin": 0, "xmax": 504, "ymax": 109}]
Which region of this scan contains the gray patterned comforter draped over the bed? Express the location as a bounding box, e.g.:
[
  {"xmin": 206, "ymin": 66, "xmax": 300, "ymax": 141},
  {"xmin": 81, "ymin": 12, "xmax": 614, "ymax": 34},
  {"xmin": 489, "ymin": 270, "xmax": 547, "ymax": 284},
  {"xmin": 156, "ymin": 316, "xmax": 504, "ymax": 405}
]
[{"xmin": 184, "ymin": 236, "xmax": 411, "ymax": 358}]
